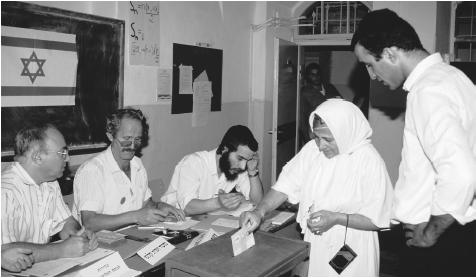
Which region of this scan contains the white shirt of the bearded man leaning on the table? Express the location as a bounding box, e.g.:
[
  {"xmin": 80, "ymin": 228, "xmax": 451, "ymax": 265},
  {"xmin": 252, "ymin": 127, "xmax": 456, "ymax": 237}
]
[{"xmin": 161, "ymin": 149, "xmax": 250, "ymax": 209}]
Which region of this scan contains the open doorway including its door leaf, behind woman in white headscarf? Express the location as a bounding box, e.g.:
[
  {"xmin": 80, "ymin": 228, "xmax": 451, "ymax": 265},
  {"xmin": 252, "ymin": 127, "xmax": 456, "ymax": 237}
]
[{"xmin": 270, "ymin": 42, "xmax": 370, "ymax": 184}]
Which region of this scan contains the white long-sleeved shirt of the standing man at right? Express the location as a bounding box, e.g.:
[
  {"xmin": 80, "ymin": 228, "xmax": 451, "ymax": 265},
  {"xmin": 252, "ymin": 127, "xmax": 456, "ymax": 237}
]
[{"xmin": 394, "ymin": 53, "xmax": 476, "ymax": 224}]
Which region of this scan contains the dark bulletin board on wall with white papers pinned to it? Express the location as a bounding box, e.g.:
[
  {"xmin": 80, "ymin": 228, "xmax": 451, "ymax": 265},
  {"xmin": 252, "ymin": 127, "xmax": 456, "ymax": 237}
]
[{"xmin": 172, "ymin": 43, "xmax": 223, "ymax": 114}]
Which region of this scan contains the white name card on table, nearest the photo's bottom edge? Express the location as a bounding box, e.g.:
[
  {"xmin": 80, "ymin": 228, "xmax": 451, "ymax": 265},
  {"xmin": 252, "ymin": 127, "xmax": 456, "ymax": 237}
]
[{"xmin": 75, "ymin": 252, "xmax": 140, "ymax": 277}]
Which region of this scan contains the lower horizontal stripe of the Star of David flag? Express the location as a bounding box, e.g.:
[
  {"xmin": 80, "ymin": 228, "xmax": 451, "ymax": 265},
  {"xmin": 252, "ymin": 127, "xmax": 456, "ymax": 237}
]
[{"xmin": 2, "ymin": 86, "xmax": 76, "ymax": 96}]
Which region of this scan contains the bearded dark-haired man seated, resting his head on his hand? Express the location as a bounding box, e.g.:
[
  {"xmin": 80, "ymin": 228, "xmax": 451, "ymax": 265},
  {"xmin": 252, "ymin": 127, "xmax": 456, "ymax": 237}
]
[{"xmin": 162, "ymin": 125, "xmax": 263, "ymax": 215}]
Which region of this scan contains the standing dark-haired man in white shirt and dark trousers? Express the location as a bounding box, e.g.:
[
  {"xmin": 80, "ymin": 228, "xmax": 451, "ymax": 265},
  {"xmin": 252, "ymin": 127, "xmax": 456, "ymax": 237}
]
[{"xmin": 351, "ymin": 9, "xmax": 476, "ymax": 276}]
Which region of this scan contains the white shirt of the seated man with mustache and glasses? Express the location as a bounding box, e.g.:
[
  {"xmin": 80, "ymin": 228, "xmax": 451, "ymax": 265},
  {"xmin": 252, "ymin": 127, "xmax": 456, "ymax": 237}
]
[{"xmin": 73, "ymin": 146, "xmax": 152, "ymax": 220}]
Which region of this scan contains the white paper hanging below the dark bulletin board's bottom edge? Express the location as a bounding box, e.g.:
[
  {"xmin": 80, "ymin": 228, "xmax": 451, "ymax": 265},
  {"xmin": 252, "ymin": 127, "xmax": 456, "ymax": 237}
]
[{"xmin": 192, "ymin": 81, "xmax": 213, "ymax": 127}]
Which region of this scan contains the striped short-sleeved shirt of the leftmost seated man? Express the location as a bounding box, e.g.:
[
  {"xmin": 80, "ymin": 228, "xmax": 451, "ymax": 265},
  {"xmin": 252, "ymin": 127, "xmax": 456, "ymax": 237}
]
[{"xmin": 2, "ymin": 162, "xmax": 71, "ymax": 244}]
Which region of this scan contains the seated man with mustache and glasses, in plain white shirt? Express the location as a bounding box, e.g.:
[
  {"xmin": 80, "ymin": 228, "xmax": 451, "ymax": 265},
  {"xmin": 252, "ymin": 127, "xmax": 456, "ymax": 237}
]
[{"xmin": 73, "ymin": 109, "xmax": 185, "ymax": 231}]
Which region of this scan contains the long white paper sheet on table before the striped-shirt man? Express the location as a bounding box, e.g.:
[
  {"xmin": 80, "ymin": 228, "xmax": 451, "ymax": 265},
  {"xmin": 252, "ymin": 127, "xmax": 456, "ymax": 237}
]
[{"xmin": 14, "ymin": 248, "xmax": 114, "ymax": 276}]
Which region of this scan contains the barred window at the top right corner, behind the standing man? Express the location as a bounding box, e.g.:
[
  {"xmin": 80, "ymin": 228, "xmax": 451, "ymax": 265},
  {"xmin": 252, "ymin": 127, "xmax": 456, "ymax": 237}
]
[{"xmin": 453, "ymin": 1, "xmax": 476, "ymax": 62}]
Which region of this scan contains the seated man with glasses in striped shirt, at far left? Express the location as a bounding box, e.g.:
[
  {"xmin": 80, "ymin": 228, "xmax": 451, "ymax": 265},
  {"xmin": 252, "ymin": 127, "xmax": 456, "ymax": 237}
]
[{"xmin": 1, "ymin": 124, "xmax": 97, "ymax": 272}]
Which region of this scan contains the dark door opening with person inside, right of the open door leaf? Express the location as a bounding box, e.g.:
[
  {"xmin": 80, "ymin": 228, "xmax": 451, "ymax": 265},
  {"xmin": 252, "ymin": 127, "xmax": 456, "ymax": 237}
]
[{"xmin": 297, "ymin": 45, "xmax": 370, "ymax": 151}]
